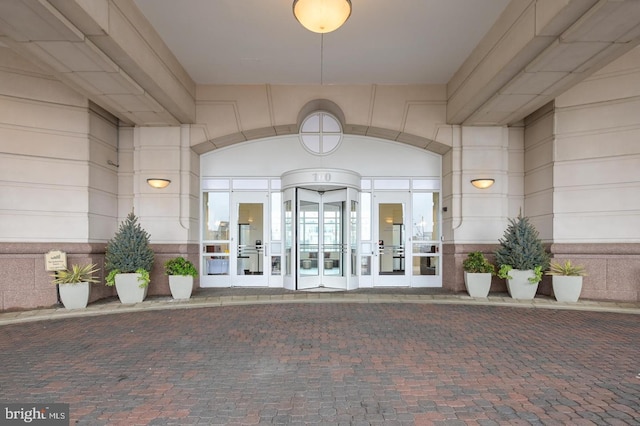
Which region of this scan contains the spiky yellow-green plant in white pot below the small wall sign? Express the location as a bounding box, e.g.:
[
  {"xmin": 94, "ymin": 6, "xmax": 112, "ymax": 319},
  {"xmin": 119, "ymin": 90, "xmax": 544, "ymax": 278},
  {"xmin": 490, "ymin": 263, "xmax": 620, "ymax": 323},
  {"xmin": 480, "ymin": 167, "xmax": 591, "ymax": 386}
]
[{"xmin": 52, "ymin": 264, "xmax": 98, "ymax": 309}]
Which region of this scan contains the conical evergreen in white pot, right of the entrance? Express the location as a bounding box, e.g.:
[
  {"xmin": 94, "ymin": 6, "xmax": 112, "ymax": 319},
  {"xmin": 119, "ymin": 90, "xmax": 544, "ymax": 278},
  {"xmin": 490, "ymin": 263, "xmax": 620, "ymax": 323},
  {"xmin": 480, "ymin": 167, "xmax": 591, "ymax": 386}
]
[{"xmin": 495, "ymin": 215, "xmax": 549, "ymax": 299}]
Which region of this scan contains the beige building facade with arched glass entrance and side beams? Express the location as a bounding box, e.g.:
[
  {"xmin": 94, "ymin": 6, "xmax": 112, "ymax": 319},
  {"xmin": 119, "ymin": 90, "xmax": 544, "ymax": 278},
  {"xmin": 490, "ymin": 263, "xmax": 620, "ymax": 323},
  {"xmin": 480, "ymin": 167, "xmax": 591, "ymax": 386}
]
[{"xmin": 0, "ymin": 0, "xmax": 640, "ymax": 310}]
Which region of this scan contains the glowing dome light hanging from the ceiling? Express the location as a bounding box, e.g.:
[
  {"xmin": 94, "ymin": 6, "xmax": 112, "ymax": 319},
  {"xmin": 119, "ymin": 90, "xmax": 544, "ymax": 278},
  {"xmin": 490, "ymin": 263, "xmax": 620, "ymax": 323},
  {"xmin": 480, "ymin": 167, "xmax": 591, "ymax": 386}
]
[{"xmin": 293, "ymin": 0, "xmax": 351, "ymax": 34}]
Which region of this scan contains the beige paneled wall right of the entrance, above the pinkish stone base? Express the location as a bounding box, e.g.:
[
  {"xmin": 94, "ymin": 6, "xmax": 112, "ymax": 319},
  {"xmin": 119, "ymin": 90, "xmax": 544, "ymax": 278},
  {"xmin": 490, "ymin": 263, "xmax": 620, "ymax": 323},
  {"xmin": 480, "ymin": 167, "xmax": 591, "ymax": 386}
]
[{"xmin": 553, "ymin": 48, "xmax": 640, "ymax": 243}]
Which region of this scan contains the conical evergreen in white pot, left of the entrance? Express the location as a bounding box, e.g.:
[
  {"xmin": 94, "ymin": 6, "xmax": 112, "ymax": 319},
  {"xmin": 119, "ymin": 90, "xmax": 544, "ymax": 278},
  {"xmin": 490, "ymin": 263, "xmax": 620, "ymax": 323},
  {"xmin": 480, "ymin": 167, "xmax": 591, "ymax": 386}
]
[{"xmin": 105, "ymin": 211, "xmax": 154, "ymax": 303}]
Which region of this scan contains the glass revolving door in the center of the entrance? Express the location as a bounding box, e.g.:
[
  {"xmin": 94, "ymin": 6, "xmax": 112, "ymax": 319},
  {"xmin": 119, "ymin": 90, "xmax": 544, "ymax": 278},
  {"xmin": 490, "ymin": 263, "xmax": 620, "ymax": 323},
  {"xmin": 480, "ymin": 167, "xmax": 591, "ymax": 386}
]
[{"xmin": 296, "ymin": 188, "xmax": 349, "ymax": 290}]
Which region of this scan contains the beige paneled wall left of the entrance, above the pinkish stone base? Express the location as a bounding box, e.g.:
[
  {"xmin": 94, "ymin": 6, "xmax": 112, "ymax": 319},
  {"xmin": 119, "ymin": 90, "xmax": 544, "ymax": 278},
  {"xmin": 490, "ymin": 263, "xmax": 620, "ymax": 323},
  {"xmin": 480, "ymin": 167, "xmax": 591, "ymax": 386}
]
[{"xmin": 0, "ymin": 48, "xmax": 117, "ymax": 242}]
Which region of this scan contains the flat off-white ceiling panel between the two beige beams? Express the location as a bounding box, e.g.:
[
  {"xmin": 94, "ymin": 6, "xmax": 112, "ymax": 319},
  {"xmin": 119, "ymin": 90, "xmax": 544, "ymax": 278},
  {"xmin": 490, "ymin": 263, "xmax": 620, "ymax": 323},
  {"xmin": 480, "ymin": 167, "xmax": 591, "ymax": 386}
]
[{"xmin": 135, "ymin": 0, "xmax": 509, "ymax": 85}]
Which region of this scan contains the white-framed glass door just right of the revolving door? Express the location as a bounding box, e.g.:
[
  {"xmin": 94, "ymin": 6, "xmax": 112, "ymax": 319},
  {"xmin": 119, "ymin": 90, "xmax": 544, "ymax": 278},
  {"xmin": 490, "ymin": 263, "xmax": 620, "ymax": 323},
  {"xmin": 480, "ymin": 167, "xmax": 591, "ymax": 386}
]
[{"xmin": 373, "ymin": 193, "xmax": 411, "ymax": 287}]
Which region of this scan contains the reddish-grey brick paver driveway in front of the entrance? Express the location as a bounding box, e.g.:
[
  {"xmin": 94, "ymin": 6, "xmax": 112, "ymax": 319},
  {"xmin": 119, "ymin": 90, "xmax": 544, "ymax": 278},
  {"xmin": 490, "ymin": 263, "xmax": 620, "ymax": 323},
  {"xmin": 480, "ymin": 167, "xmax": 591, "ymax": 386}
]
[{"xmin": 0, "ymin": 303, "xmax": 640, "ymax": 425}]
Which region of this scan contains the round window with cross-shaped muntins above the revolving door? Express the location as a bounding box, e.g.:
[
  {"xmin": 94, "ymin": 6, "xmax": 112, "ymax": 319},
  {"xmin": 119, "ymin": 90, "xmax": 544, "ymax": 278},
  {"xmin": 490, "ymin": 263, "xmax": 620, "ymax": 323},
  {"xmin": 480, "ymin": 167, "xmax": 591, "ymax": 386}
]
[{"xmin": 300, "ymin": 111, "xmax": 342, "ymax": 155}]
